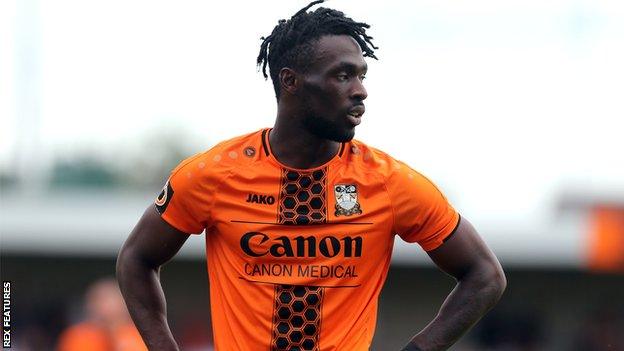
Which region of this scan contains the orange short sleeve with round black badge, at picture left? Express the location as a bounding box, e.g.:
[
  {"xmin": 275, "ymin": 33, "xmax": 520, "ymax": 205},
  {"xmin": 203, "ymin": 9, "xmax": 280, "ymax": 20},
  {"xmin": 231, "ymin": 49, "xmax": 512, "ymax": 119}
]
[{"xmin": 154, "ymin": 154, "xmax": 211, "ymax": 234}]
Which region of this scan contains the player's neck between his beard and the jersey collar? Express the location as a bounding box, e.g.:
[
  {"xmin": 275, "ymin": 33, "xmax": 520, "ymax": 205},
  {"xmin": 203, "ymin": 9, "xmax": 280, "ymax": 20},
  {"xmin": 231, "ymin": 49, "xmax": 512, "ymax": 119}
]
[{"xmin": 269, "ymin": 106, "xmax": 340, "ymax": 169}]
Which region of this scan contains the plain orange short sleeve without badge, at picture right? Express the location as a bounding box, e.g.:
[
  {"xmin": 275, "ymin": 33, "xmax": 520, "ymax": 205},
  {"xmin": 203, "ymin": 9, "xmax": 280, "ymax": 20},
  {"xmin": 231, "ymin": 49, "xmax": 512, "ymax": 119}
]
[{"xmin": 386, "ymin": 161, "xmax": 459, "ymax": 251}]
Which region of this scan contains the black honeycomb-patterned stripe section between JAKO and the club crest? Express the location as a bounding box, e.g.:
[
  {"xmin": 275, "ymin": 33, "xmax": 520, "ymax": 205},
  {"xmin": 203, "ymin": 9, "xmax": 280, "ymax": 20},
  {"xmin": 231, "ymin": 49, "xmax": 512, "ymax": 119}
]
[{"xmin": 278, "ymin": 168, "xmax": 327, "ymax": 225}]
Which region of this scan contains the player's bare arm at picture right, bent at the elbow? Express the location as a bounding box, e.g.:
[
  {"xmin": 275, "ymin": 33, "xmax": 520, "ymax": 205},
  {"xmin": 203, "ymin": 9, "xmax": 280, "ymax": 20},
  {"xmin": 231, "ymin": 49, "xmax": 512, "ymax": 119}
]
[{"xmin": 403, "ymin": 218, "xmax": 507, "ymax": 351}]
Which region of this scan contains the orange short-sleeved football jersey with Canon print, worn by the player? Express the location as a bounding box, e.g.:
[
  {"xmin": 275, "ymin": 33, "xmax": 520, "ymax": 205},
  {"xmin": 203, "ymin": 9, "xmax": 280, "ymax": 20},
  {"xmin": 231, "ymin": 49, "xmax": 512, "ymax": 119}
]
[{"xmin": 156, "ymin": 129, "xmax": 459, "ymax": 351}]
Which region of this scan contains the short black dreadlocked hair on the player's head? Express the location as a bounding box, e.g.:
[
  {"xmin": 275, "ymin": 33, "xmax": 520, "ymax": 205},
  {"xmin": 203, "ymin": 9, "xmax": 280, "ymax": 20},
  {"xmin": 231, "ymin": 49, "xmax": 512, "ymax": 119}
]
[{"xmin": 257, "ymin": 0, "xmax": 379, "ymax": 100}]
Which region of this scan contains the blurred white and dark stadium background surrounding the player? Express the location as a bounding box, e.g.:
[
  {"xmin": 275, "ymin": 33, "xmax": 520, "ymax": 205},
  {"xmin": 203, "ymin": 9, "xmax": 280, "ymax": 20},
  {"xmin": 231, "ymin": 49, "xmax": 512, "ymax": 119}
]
[{"xmin": 0, "ymin": 0, "xmax": 624, "ymax": 351}]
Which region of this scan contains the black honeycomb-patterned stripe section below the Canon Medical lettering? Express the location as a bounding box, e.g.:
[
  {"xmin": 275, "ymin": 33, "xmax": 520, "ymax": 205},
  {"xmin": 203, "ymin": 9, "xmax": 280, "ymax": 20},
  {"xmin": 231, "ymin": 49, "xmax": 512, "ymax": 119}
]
[{"xmin": 271, "ymin": 285, "xmax": 324, "ymax": 351}]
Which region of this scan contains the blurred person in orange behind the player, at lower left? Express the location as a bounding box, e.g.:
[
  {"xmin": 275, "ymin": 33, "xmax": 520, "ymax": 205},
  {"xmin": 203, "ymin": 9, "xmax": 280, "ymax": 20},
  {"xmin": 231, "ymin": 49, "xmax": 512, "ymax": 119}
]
[{"xmin": 57, "ymin": 278, "xmax": 147, "ymax": 351}]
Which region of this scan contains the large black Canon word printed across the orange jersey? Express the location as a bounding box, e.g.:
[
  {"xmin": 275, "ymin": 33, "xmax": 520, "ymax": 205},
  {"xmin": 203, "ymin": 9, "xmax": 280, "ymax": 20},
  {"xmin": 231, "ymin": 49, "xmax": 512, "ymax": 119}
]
[{"xmin": 240, "ymin": 232, "xmax": 362, "ymax": 257}]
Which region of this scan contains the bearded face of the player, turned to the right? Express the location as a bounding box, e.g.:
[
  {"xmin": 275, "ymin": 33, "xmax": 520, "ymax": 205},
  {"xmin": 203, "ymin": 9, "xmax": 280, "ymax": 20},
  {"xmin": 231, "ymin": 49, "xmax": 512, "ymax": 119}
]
[{"xmin": 298, "ymin": 35, "xmax": 367, "ymax": 142}]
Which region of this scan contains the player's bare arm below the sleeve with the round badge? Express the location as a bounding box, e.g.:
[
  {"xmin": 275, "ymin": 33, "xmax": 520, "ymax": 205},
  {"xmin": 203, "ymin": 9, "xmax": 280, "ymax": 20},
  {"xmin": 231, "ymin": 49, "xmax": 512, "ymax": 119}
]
[{"xmin": 117, "ymin": 205, "xmax": 189, "ymax": 351}]
